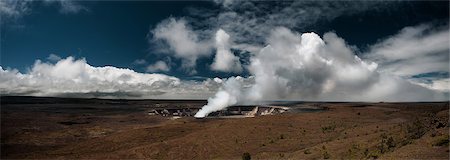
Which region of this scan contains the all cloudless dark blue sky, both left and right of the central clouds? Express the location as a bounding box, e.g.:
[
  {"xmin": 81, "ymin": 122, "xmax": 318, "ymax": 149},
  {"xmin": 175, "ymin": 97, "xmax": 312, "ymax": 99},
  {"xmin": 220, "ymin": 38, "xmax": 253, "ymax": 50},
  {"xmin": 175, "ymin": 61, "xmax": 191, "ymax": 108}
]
[{"xmin": 1, "ymin": 1, "xmax": 449, "ymax": 78}]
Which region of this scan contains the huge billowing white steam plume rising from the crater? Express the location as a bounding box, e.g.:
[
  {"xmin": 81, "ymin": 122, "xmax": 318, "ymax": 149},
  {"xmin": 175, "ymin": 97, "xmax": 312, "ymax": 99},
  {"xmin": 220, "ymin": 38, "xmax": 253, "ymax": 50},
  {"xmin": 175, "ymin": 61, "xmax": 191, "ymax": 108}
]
[{"xmin": 196, "ymin": 27, "xmax": 446, "ymax": 117}]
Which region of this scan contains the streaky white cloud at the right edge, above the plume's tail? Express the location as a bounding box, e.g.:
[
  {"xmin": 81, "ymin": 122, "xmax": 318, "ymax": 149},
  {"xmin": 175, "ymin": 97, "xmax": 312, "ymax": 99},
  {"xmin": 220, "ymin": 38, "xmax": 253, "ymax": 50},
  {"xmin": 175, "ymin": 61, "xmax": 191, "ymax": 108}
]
[{"xmin": 365, "ymin": 24, "xmax": 450, "ymax": 91}]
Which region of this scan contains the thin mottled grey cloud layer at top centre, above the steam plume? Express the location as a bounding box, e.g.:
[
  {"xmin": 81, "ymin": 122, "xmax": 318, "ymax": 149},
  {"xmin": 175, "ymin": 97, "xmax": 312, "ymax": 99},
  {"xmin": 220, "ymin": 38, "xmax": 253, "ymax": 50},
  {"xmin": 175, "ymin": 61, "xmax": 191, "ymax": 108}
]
[{"xmin": 179, "ymin": 0, "xmax": 395, "ymax": 54}]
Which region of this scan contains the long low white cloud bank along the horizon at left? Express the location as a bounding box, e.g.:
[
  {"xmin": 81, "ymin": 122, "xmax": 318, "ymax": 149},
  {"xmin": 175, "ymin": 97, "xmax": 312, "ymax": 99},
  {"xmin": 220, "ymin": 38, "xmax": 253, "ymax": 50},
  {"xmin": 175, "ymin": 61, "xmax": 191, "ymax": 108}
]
[{"xmin": 0, "ymin": 57, "xmax": 215, "ymax": 98}]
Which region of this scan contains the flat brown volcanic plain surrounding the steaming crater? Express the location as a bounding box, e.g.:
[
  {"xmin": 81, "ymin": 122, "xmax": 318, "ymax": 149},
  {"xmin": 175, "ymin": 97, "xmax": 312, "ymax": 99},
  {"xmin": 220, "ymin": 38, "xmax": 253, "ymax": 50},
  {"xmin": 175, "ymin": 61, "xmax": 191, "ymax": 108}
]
[{"xmin": 1, "ymin": 97, "xmax": 449, "ymax": 159}]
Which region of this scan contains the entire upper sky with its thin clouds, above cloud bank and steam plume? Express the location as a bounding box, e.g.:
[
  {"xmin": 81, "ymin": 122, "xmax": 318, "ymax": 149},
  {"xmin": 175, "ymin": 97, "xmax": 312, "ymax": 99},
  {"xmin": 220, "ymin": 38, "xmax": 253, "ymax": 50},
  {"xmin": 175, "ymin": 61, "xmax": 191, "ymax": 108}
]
[{"xmin": 1, "ymin": 1, "xmax": 449, "ymax": 99}]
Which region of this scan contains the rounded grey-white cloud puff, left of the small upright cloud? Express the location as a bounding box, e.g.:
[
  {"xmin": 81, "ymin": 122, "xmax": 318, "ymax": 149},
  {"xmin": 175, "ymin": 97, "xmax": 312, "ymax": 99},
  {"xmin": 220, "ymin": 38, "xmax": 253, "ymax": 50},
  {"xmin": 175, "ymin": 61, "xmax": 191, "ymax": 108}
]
[{"xmin": 150, "ymin": 18, "xmax": 212, "ymax": 69}]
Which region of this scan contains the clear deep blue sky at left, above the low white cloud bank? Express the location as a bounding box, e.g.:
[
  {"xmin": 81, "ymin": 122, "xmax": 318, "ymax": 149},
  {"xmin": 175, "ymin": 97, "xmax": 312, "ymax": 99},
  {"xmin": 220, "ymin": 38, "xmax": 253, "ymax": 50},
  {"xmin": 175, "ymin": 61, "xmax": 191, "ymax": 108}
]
[{"xmin": 1, "ymin": 1, "xmax": 214, "ymax": 76}]
